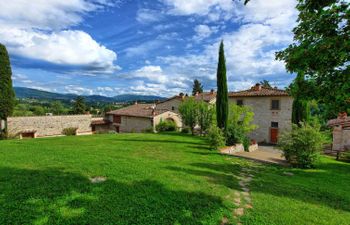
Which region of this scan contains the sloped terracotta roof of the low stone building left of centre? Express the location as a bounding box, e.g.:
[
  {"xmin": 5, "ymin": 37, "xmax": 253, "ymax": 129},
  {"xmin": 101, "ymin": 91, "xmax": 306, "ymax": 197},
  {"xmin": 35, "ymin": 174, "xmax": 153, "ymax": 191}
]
[{"xmin": 107, "ymin": 104, "xmax": 169, "ymax": 118}]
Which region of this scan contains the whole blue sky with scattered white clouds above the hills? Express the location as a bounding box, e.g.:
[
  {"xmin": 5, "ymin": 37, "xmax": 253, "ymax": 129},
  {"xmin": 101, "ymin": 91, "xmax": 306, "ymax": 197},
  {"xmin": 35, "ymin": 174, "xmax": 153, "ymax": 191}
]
[{"xmin": 0, "ymin": 0, "xmax": 297, "ymax": 96}]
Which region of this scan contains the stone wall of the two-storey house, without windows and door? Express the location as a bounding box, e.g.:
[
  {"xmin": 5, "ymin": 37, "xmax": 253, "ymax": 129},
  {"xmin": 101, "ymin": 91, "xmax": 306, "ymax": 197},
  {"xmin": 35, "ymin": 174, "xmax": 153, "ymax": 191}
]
[{"xmin": 229, "ymin": 96, "xmax": 293, "ymax": 143}]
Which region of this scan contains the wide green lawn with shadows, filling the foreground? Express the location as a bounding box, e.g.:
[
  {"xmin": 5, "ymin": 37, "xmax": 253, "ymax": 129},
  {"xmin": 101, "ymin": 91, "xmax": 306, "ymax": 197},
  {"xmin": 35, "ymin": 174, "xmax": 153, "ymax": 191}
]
[{"xmin": 0, "ymin": 134, "xmax": 350, "ymax": 225}]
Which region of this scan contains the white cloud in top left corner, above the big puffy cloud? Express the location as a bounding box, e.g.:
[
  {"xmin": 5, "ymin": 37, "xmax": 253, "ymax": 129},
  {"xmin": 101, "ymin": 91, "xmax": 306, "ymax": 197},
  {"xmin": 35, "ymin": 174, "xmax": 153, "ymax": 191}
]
[{"xmin": 0, "ymin": 0, "xmax": 119, "ymax": 30}]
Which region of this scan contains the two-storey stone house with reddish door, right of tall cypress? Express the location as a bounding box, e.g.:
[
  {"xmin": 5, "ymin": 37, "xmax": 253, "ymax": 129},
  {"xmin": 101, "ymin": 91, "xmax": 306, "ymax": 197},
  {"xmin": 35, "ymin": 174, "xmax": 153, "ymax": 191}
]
[{"xmin": 229, "ymin": 84, "xmax": 293, "ymax": 144}]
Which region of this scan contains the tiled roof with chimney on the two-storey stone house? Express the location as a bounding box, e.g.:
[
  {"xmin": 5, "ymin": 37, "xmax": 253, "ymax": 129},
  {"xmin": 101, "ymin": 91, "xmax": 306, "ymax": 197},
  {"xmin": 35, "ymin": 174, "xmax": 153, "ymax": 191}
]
[{"xmin": 229, "ymin": 84, "xmax": 289, "ymax": 97}]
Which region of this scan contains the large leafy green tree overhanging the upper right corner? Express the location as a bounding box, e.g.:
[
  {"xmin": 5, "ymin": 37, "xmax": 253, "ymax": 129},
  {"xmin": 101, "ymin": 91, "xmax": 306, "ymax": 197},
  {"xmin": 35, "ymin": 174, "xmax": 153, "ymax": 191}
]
[{"xmin": 276, "ymin": 0, "xmax": 350, "ymax": 118}]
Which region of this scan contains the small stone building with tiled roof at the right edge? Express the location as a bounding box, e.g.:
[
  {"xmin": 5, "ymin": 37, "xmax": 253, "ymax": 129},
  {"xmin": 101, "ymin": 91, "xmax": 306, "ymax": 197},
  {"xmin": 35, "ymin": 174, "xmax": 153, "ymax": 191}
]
[{"xmin": 328, "ymin": 113, "xmax": 350, "ymax": 152}]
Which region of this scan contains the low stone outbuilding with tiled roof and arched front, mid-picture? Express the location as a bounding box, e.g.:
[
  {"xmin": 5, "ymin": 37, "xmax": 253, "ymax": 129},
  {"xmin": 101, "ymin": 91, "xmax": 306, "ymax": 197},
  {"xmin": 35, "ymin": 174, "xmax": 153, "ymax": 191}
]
[{"xmin": 92, "ymin": 103, "xmax": 182, "ymax": 133}]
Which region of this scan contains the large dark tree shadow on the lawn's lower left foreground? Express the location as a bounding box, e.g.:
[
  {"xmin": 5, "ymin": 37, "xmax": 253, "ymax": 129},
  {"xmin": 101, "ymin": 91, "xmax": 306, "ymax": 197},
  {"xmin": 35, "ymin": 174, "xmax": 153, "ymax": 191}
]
[{"xmin": 0, "ymin": 168, "xmax": 225, "ymax": 225}]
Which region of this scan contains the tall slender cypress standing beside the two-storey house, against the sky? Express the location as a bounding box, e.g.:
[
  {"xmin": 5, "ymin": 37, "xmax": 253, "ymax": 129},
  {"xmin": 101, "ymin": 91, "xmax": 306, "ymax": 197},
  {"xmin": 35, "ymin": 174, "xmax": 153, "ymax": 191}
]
[{"xmin": 216, "ymin": 41, "xmax": 228, "ymax": 129}]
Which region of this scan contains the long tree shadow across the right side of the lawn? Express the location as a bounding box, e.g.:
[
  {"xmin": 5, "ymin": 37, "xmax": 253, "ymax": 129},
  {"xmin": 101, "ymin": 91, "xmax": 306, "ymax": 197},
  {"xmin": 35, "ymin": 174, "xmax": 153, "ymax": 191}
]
[{"xmin": 167, "ymin": 160, "xmax": 350, "ymax": 212}]
